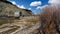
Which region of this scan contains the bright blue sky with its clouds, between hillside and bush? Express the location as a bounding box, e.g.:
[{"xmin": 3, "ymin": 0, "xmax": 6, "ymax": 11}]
[{"xmin": 9, "ymin": 0, "xmax": 49, "ymax": 14}]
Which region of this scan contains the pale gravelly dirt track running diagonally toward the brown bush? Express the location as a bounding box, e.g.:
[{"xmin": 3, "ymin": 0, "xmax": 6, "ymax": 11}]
[{"xmin": 12, "ymin": 23, "xmax": 41, "ymax": 34}]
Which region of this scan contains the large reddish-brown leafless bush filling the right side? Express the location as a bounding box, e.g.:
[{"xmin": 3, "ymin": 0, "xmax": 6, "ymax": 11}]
[{"xmin": 39, "ymin": 5, "xmax": 60, "ymax": 34}]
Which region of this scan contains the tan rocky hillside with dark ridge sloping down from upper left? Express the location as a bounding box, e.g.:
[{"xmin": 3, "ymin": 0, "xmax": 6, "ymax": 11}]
[{"xmin": 0, "ymin": 0, "xmax": 32, "ymax": 16}]
